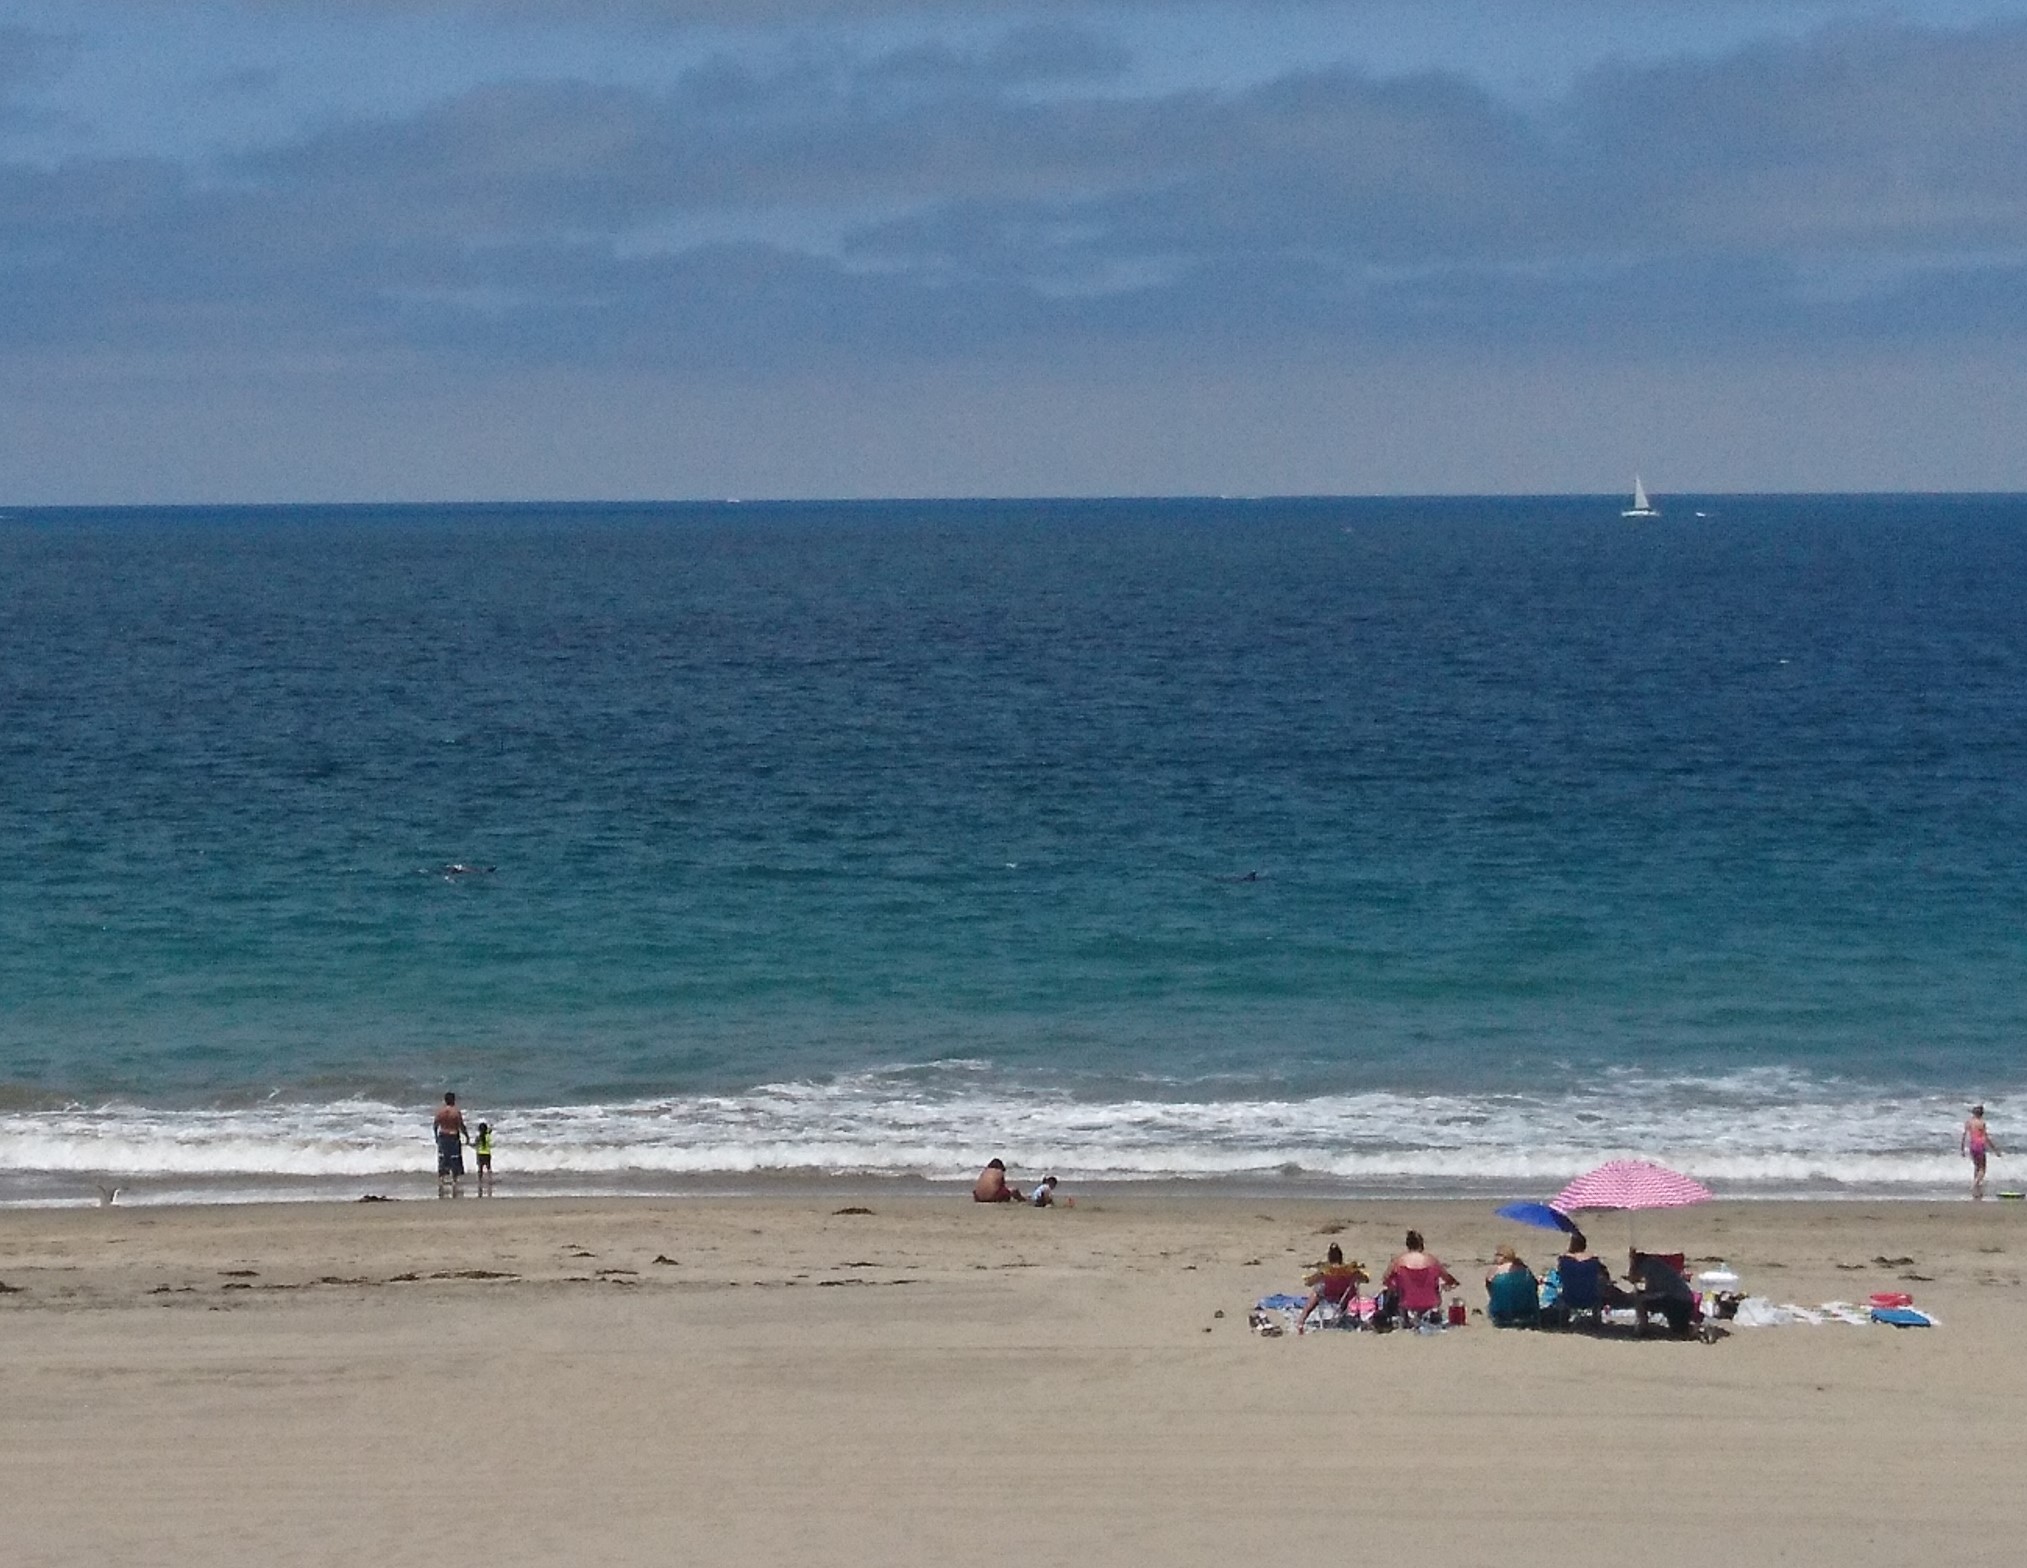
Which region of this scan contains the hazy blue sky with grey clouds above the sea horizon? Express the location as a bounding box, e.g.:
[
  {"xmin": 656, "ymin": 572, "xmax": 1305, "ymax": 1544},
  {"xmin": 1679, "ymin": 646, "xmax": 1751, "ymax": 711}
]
[{"xmin": 0, "ymin": 0, "xmax": 2027, "ymax": 508}]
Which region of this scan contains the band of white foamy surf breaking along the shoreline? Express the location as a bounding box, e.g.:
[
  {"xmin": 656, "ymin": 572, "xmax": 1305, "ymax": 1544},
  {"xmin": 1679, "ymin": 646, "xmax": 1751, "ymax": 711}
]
[{"xmin": 0, "ymin": 1062, "xmax": 1999, "ymax": 1201}]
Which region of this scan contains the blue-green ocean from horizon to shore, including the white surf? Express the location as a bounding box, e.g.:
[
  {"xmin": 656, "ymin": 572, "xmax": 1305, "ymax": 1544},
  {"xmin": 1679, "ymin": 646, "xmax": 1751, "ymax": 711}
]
[{"xmin": 0, "ymin": 496, "xmax": 2027, "ymax": 1203}]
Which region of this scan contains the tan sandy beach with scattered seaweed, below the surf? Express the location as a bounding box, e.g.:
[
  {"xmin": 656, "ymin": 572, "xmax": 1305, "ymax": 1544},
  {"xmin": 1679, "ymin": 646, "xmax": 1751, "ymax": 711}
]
[{"xmin": 0, "ymin": 1187, "xmax": 2027, "ymax": 1568}]
